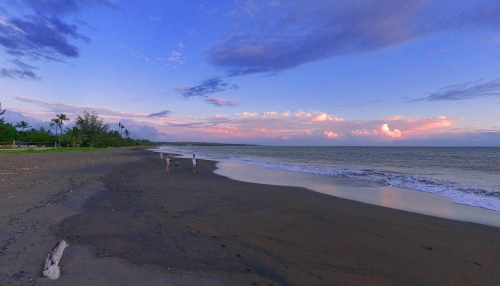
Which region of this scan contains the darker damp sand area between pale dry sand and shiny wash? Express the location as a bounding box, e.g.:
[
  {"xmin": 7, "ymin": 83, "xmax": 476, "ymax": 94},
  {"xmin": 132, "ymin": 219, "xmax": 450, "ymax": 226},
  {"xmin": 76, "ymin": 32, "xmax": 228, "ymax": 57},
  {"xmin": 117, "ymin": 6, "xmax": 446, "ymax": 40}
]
[{"xmin": 57, "ymin": 152, "xmax": 500, "ymax": 285}]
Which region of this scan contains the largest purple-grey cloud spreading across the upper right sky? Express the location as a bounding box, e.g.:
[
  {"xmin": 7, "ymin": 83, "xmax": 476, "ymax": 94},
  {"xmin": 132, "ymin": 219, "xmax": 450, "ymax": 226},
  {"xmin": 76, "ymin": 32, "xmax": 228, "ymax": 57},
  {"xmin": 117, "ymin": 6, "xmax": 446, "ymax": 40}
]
[{"xmin": 208, "ymin": 0, "xmax": 500, "ymax": 76}]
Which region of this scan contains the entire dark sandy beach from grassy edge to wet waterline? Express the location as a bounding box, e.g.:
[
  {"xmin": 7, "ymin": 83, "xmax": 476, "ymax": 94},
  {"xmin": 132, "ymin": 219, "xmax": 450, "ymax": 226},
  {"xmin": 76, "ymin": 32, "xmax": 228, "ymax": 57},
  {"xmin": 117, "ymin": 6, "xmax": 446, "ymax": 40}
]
[{"xmin": 0, "ymin": 149, "xmax": 500, "ymax": 286}]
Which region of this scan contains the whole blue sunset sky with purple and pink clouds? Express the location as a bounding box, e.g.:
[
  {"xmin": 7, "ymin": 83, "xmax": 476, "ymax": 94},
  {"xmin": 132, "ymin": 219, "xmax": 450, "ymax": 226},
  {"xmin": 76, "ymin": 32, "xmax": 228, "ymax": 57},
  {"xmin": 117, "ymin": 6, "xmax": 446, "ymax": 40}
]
[{"xmin": 0, "ymin": 0, "xmax": 500, "ymax": 146}]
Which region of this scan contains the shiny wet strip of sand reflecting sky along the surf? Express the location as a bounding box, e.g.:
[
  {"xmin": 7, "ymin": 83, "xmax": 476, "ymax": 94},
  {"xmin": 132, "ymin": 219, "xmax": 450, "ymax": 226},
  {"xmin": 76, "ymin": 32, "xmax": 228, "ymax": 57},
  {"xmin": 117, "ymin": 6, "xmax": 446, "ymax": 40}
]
[{"xmin": 214, "ymin": 161, "xmax": 500, "ymax": 228}]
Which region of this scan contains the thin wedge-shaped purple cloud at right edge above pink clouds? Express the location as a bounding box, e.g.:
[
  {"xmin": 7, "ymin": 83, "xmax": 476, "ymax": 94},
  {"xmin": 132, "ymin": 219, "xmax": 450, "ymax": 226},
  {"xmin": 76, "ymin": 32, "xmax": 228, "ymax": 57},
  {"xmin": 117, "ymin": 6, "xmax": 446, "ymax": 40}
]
[{"xmin": 412, "ymin": 78, "xmax": 500, "ymax": 102}]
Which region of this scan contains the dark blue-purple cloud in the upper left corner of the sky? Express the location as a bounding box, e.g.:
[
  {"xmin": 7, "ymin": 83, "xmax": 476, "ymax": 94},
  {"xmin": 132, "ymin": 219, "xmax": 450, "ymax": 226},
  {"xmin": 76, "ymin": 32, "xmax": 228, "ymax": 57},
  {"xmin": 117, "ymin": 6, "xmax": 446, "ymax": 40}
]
[{"xmin": 0, "ymin": 0, "xmax": 118, "ymax": 78}]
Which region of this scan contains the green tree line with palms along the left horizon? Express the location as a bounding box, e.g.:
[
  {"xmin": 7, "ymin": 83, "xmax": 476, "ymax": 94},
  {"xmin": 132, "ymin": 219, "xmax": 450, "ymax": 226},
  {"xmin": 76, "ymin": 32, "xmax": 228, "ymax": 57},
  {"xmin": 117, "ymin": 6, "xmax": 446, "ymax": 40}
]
[{"xmin": 0, "ymin": 103, "xmax": 153, "ymax": 147}]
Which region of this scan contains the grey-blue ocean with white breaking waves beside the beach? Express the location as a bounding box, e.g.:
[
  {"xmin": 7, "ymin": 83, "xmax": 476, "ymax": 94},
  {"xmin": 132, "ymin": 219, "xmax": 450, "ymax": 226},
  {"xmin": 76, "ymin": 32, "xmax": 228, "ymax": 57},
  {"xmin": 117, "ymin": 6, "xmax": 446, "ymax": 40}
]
[{"xmin": 160, "ymin": 146, "xmax": 500, "ymax": 211}]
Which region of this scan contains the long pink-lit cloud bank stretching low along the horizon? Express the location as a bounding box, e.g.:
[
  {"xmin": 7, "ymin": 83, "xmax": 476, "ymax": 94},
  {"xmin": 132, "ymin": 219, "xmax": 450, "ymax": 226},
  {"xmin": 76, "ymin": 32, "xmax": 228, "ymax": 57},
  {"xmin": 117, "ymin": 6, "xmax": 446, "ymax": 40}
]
[{"xmin": 3, "ymin": 98, "xmax": 500, "ymax": 146}]
